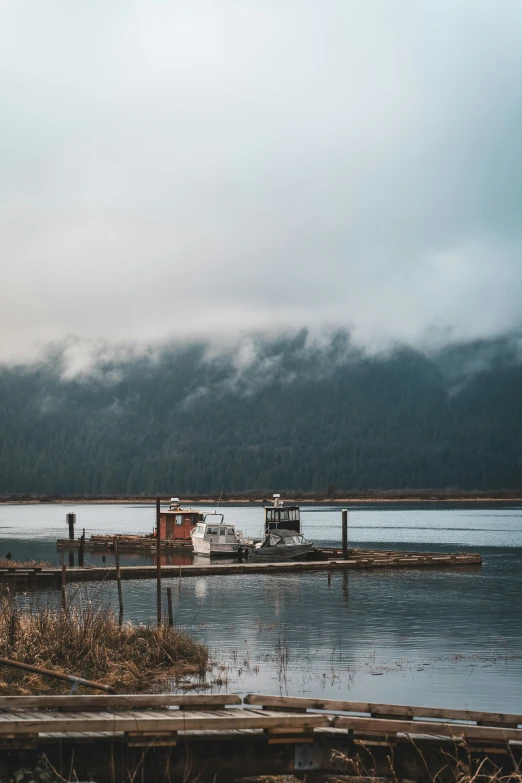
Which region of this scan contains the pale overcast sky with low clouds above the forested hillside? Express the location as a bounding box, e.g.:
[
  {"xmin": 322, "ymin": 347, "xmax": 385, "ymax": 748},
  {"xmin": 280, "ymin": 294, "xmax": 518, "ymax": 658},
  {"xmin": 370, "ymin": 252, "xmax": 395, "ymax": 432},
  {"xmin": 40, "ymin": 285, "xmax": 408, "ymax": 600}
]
[{"xmin": 0, "ymin": 0, "xmax": 522, "ymax": 358}]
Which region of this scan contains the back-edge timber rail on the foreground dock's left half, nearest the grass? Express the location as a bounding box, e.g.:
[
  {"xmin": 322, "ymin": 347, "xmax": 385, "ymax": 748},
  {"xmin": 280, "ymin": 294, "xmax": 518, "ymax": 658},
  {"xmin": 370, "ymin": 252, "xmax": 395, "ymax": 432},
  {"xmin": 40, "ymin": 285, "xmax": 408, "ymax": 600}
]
[{"xmin": 0, "ymin": 693, "xmax": 241, "ymax": 712}]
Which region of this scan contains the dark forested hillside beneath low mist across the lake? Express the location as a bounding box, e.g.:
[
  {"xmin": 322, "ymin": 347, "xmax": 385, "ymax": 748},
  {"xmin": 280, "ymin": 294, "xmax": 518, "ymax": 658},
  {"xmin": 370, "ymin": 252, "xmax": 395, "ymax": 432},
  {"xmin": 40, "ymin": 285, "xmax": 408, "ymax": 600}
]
[{"xmin": 0, "ymin": 333, "xmax": 522, "ymax": 494}]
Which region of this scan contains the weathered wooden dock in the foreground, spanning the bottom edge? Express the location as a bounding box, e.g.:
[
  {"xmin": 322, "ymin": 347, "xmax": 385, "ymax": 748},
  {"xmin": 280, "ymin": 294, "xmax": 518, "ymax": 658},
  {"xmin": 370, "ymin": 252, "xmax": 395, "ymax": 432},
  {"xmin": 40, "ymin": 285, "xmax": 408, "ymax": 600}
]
[{"xmin": 0, "ymin": 694, "xmax": 522, "ymax": 783}]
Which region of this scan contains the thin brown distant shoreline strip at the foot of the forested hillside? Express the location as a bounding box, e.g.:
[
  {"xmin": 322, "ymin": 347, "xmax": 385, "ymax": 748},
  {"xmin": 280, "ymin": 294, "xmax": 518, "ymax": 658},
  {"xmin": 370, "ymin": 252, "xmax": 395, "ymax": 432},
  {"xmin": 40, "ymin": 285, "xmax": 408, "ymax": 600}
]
[{"xmin": 0, "ymin": 490, "xmax": 522, "ymax": 506}]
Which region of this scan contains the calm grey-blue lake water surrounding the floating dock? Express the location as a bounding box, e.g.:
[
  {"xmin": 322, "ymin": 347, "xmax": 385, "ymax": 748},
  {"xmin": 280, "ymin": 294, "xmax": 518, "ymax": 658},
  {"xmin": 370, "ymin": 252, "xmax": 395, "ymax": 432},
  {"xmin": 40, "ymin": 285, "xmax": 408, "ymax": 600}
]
[{"xmin": 0, "ymin": 504, "xmax": 522, "ymax": 711}]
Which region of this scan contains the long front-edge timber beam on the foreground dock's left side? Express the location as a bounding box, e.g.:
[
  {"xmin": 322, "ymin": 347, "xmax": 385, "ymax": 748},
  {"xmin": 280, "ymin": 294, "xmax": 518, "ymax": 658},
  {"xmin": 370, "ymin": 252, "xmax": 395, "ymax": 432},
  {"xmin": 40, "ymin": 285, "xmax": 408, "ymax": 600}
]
[{"xmin": 0, "ymin": 709, "xmax": 331, "ymax": 737}]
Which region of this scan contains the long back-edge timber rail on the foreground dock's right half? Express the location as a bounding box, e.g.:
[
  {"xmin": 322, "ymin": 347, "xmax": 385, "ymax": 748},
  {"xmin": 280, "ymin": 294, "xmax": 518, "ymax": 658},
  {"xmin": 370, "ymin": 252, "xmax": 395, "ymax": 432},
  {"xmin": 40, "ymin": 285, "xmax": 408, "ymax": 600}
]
[{"xmin": 244, "ymin": 693, "xmax": 522, "ymax": 728}]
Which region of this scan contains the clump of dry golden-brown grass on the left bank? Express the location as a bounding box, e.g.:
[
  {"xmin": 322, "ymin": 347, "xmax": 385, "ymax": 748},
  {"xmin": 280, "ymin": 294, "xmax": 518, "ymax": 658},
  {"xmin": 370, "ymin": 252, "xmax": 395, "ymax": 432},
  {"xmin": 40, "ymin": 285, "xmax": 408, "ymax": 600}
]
[{"xmin": 0, "ymin": 594, "xmax": 208, "ymax": 695}]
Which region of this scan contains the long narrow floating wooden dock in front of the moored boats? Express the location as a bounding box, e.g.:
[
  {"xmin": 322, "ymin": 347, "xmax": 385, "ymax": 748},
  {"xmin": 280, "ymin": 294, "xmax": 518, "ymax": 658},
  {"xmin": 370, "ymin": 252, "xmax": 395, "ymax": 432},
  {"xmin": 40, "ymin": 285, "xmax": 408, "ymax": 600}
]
[{"xmin": 0, "ymin": 549, "xmax": 482, "ymax": 588}]
